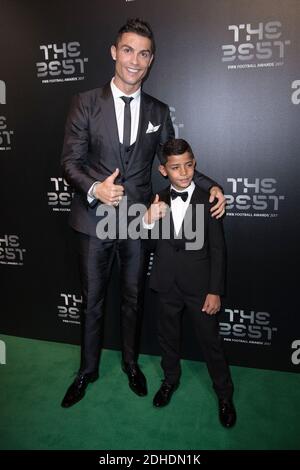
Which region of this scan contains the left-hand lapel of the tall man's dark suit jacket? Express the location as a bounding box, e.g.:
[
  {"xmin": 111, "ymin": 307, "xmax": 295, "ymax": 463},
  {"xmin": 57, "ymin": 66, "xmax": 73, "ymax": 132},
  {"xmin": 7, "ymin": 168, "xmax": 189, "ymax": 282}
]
[{"xmin": 101, "ymin": 83, "xmax": 125, "ymax": 174}]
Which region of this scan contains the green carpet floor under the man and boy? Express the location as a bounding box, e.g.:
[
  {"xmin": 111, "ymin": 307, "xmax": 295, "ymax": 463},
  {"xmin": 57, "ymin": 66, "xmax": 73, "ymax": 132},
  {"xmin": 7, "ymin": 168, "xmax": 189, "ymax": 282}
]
[{"xmin": 0, "ymin": 335, "xmax": 300, "ymax": 450}]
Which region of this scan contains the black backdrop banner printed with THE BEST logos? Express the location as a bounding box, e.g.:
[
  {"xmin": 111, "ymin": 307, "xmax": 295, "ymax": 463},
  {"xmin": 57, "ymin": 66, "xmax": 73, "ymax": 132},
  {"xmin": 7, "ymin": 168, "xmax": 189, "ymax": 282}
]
[{"xmin": 0, "ymin": 0, "xmax": 300, "ymax": 372}]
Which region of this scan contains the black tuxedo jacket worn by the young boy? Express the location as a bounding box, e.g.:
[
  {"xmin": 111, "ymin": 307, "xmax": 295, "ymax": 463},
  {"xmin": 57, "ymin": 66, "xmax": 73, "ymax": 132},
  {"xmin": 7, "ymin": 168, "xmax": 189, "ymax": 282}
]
[{"xmin": 148, "ymin": 186, "xmax": 225, "ymax": 298}]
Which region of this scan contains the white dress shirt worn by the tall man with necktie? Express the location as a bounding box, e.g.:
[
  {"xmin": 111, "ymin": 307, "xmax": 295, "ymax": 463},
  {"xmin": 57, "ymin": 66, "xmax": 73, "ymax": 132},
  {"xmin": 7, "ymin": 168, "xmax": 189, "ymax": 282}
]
[{"xmin": 87, "ymin": 78, "xmax": 141, "ymax": 203}]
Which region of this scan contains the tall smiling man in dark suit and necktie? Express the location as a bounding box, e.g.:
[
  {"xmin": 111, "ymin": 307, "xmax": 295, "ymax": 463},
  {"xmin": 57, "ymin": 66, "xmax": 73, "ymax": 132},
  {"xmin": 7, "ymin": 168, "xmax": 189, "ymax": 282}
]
[{"xmin": 62, "ymin": 19, "xmax": 225, "ymax": 407}]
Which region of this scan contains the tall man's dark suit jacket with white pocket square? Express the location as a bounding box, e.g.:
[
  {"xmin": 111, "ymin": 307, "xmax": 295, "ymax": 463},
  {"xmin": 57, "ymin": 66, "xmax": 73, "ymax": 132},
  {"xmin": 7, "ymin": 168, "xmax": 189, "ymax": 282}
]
[{"xmin": 61, "ymin": 83, "xmax": 216, "ymax": 236}]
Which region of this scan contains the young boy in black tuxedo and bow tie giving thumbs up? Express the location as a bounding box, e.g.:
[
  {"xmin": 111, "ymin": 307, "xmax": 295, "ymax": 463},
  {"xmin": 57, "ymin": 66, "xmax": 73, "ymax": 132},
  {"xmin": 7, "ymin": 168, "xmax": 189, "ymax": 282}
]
[{"xmin": 143, "ymin": 139, "xmax": 236, "ymax": 428}]
